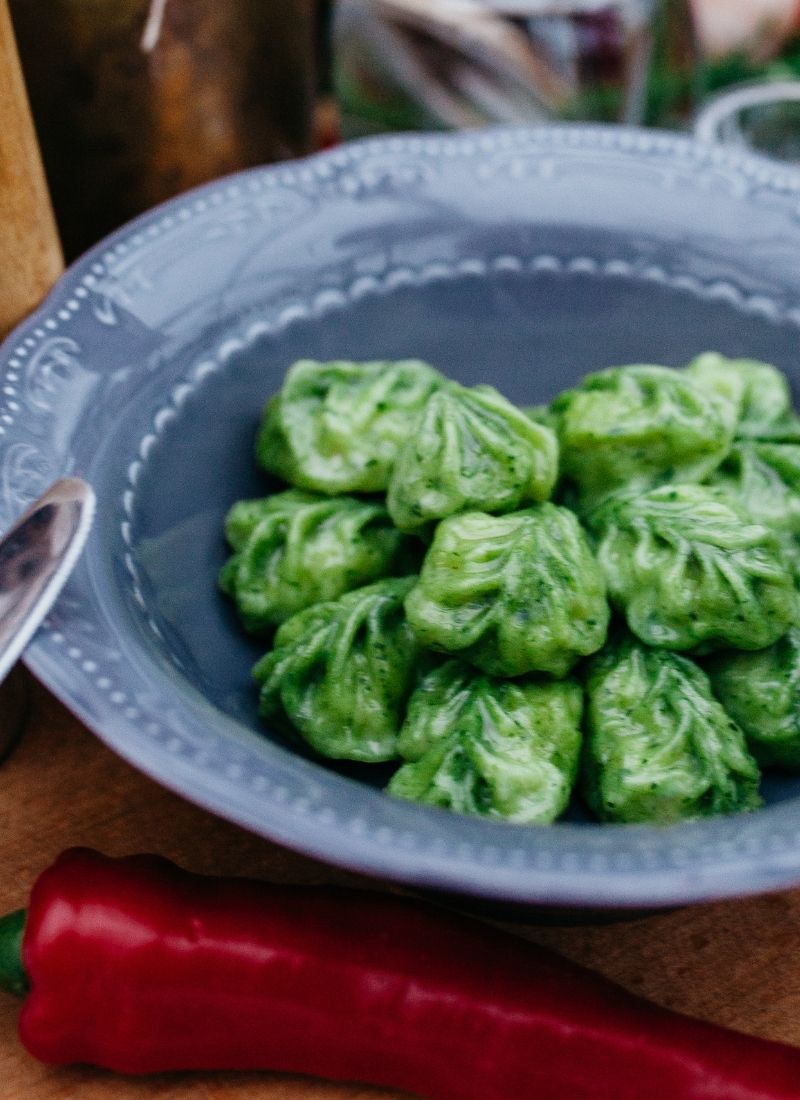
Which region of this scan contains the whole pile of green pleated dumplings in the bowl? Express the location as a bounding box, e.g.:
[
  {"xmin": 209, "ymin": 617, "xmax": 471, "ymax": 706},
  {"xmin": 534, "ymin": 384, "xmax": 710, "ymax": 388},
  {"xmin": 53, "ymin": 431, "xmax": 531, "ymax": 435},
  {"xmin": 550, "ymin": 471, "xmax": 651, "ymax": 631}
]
[{"xmin": 219, "ymin": 352, "xmax": 800, "ymax": 824}]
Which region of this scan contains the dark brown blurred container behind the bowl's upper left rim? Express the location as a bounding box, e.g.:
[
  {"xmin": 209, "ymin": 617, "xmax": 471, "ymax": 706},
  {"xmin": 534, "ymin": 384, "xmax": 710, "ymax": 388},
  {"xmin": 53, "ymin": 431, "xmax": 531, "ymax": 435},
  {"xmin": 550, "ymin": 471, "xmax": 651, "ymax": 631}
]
[{"xmin": 10, "ymin": 0, "xmax": 315, "ymax": 257}]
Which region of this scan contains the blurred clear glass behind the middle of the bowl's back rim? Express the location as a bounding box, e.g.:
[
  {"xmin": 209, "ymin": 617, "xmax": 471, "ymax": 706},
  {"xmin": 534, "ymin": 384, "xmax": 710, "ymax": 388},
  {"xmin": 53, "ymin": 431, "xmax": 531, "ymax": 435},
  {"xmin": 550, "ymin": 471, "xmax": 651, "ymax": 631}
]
[{"xmin": 333, "ymin": 0, "xmax": 699, "ymax": 135}]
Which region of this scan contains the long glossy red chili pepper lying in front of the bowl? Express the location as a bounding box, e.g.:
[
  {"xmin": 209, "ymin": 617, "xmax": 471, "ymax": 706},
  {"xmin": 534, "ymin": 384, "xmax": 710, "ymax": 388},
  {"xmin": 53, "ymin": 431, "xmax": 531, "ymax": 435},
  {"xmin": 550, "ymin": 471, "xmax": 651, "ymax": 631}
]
[{"xmin": 0, "ymin": 849, "xmax": 800, "ymax": 1100}]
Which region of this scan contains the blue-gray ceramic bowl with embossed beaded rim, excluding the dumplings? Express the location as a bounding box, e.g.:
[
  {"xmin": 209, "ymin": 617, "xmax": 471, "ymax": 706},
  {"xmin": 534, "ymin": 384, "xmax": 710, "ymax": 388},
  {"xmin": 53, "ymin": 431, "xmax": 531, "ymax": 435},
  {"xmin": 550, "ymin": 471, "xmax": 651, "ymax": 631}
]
[{"xmin": 7, "ymin": 128, "xmax": 800, "ymax": 908}]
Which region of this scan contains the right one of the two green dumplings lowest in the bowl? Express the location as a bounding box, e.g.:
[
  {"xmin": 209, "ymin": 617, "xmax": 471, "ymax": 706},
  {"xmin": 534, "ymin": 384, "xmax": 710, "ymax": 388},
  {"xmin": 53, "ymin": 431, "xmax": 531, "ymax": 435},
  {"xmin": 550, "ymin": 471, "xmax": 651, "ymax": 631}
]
[{"xmin": 582, "ymin": 638, "xmax": 761, "ymax": 825}]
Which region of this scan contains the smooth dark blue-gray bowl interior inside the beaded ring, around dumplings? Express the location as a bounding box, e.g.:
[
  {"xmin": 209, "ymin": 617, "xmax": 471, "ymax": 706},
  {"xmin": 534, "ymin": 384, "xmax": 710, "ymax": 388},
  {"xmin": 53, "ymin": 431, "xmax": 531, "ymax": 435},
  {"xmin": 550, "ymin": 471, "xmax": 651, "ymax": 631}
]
[{"xmin": 111, "ymin": 264, "xmax": 800, "ymax": 821}]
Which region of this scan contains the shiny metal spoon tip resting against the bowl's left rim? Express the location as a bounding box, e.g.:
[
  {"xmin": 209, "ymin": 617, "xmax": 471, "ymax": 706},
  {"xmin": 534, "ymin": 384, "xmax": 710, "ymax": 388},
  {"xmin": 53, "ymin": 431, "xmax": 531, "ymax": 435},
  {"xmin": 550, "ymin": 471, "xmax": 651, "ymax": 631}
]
[{"xmin": 0, "ymin": 477, "xmax": 96, "ymax": 760}]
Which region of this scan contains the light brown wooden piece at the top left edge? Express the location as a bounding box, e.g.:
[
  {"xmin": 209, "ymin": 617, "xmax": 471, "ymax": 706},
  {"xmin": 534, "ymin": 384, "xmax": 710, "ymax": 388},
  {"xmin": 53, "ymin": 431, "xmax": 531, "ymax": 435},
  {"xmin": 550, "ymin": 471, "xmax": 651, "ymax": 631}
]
[{"xmin": 0, "ymin": 0, "xmax": 63, "ymax": 337}]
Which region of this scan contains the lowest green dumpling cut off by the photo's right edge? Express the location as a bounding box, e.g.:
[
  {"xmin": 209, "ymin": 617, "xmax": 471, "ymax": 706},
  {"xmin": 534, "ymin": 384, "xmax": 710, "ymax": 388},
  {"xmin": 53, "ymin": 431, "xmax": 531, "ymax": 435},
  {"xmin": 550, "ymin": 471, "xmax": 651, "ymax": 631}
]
[{"xmin": 706, "ymin": 627, "xmax": 800, "ymax": 769}]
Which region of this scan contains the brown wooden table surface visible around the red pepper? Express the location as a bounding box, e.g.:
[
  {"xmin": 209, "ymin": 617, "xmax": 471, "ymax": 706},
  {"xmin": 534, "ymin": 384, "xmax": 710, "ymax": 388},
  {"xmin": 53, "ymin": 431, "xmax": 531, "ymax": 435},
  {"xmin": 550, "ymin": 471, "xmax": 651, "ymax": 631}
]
[{"xmin": 0, "ymin": 673, "xmax": 800, "ymax": 1100}]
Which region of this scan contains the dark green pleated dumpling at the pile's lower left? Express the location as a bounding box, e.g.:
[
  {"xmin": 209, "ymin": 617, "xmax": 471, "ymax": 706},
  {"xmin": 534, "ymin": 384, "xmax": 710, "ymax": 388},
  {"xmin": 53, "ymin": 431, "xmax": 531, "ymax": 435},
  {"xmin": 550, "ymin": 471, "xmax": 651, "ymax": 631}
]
[{"xmin": 253, "ymin": 578, "xmax": 419, "ymax": 762}]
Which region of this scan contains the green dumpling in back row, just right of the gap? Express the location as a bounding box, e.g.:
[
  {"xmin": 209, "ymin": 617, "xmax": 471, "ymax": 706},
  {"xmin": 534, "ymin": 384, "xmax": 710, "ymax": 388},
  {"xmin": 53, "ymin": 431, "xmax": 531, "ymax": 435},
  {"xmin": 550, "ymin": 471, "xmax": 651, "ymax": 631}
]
[{"xmin": 551, "ymin": 364, "xmax": 735, "ymax": 507}]
